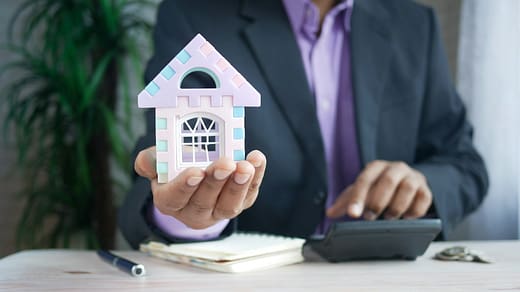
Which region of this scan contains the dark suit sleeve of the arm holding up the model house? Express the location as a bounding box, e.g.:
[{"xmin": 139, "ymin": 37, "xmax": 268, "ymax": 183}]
[{"xmin": 118, "ymin": 0, "xmax": 236, "ymax": 248}]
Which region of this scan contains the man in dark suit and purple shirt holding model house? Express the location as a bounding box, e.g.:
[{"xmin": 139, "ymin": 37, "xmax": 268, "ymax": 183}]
[{"xmin": 119, "ymin": 0, "xmax": 488, "ymax": 247}]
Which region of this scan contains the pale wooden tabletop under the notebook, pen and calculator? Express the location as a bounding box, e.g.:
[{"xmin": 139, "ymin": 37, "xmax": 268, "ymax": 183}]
[{"xmin": 0, "ymin": 241, "xmax": 520, "ymax": 291}]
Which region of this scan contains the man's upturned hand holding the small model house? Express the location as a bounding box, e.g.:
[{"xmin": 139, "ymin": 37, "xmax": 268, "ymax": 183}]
[{"xmin": 134, "ymin": 147, "xmax": 266, "ymax": 229}]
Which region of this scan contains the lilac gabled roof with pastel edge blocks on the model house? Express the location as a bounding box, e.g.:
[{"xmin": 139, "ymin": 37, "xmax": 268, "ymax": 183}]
[{"xmin": 137, "ymin": 34, "xmax": 260, "ymax": 108}]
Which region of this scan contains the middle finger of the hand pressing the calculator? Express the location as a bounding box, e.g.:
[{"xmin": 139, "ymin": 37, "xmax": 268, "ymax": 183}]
[{"xmin": 363, "ymin": 162, "xmax": 411, "ymax": 220}]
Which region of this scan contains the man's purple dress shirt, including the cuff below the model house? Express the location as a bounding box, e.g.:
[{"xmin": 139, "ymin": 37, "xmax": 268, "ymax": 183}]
[{"xmin": 153, "ymin": 0, "xmax": 360, "ymax": 239}]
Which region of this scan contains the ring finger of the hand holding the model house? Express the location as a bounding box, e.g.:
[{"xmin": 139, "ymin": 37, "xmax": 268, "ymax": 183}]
[{"xmin": 213, "ymin": 161, "xmax": 255, "ymax": 220}]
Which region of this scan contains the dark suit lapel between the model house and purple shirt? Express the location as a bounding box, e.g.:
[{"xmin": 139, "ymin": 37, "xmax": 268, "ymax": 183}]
[{"xmin": 242, "ymin": 0, "xmax": 326, "ymax": 185}]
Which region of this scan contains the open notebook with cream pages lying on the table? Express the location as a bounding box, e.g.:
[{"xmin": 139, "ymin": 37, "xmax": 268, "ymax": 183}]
[{"xmin": 140, "ymin": 233, "xmax": 305, "ymax": 273}]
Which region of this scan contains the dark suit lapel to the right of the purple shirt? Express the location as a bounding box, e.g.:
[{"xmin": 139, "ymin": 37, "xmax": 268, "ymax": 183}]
[{"xmin": 351, "ymin": 0, "xmax": 392, "ymax": 165}]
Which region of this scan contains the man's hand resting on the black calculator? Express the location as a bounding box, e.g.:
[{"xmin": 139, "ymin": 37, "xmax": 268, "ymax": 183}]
[{"xmin": 327, "ymin": 161, "xmax": 432, "ymax": 220}]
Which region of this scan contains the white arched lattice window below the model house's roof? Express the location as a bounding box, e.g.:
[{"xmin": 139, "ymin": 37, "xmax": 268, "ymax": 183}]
[{"xmin": 179, "ymin": 114, "xmax": 222, "ymax": 166}]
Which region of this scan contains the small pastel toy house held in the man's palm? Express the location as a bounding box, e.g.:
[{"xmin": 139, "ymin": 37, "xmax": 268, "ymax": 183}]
[{"xmin": 138, "ymin": 34, "xmax": 260, "ymax": 183}]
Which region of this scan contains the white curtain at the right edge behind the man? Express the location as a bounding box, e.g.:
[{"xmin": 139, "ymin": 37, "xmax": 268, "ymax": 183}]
[{"xmin": 450, "ymin": 0, "xmax": 520, "ymax": 239}]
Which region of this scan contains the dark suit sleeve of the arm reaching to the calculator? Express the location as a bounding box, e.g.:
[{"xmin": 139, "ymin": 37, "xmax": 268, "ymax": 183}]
[{"xmin": 413, "ymin": 10, "xmax": 488, "ymax": 235}]
